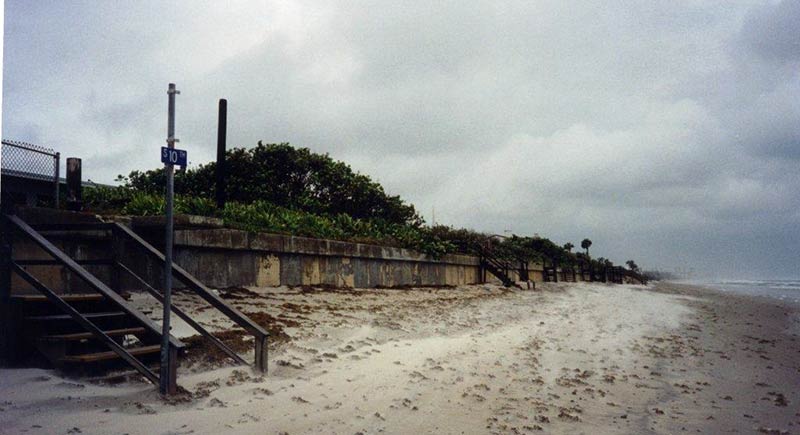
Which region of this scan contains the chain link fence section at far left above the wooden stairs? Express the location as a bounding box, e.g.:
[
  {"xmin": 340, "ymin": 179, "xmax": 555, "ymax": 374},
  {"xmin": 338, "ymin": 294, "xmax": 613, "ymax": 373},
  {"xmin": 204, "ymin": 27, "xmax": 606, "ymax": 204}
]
[{"xmin": 0, "ymin": 139, "xmax": 61, "ymax": 208}]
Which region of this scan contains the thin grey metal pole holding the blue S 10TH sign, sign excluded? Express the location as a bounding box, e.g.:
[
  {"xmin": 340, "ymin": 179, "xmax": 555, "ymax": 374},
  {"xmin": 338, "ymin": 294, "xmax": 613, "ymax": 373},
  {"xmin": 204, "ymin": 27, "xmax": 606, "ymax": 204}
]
[{"xmin": 159, "ymin": 83, "xmax": 180, "ymax": 395}]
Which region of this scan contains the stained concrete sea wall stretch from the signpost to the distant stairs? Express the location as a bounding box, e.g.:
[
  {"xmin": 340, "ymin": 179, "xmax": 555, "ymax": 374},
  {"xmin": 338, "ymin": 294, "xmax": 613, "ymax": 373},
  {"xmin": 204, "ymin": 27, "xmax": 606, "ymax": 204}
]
[{"xmin": 175, "ymin": 229, "xmax": 480, "ymax": 287}]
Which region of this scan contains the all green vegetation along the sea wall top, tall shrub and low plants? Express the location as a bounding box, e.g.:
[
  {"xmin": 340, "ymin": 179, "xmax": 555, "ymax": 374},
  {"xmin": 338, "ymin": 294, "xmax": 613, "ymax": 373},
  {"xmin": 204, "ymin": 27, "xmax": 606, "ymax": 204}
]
[{"xmin": 84, "ymin": 142, "xmax": 624, "ymax": 267}]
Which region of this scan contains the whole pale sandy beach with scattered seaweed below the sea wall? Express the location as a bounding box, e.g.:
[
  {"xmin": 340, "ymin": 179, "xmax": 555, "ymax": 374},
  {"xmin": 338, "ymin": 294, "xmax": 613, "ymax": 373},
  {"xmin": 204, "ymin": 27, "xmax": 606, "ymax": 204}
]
[{"xmin": 0, "ymin": 283, "xmax": 800, "ymax": 434}]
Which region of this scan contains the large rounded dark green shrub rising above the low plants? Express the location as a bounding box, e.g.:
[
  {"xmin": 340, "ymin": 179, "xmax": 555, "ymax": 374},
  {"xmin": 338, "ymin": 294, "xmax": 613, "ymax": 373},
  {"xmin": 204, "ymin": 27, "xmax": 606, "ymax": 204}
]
[{"xmin": 118, "ymin": 142, "xmax": 422, "ymax": 225}]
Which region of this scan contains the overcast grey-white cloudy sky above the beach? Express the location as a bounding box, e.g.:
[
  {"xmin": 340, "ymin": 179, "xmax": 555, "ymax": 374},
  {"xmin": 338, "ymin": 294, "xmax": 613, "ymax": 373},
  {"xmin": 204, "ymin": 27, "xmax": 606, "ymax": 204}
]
[{"xmin": 2, "ymin": 0, "xmax": 800, "ymax": 278}]
